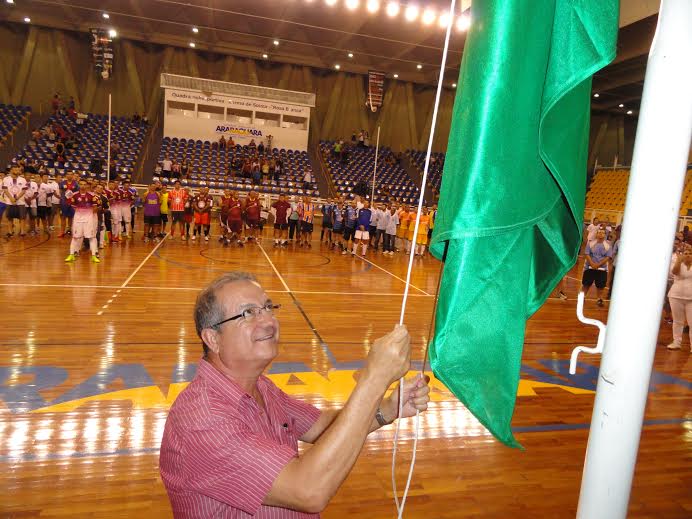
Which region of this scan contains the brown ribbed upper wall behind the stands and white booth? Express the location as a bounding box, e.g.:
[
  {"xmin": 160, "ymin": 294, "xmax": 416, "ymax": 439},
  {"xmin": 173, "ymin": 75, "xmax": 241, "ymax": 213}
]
[{"xmin": 0, "ymin": 22, "xmax": 456, "ymax": 151}]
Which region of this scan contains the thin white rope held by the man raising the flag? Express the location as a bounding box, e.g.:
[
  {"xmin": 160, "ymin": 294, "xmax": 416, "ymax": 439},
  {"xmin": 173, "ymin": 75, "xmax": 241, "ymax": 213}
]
[{"xmin": 392, "ymin": 0, "xmax": 456, "ymax": 519}]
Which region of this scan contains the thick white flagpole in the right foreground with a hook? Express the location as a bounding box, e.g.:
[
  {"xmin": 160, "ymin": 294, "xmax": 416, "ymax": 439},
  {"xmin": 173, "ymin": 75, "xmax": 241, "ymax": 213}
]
[{"xmin": 577, "ymin": 0, "xmax": 692, "ymax": 519}]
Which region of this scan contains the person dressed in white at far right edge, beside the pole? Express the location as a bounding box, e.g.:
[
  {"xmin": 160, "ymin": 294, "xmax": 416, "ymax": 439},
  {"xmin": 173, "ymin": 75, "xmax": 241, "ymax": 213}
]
[{"xmin": 668, "ymin": 243, "xmax": 692, "ymax": 352}]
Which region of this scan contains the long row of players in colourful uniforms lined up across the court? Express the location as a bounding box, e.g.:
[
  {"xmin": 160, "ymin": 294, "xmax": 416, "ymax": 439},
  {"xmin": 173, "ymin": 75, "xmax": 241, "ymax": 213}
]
[{"xmin": 0, "ymin": 167, "xmax": 437, "ymax": 263}]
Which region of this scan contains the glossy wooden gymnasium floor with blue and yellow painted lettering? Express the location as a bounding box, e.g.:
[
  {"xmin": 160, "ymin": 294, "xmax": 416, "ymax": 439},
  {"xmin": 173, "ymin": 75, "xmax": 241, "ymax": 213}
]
[{"xmin": 0, "ymin": 220, "xmax": 692, "ymax": 519}]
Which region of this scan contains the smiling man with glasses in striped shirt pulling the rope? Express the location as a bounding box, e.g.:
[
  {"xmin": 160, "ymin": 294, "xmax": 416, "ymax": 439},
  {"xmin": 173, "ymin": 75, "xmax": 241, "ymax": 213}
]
[{"xmin": 160, "ymin": 272, "xmax": 429, "ymax": 519}]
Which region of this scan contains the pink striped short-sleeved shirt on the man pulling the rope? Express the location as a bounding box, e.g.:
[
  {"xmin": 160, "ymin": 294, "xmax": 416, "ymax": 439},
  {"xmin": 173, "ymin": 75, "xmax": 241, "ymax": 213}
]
[{"xmin": 159, "ymin": 359, "xmax": 320, "ymax": 519}]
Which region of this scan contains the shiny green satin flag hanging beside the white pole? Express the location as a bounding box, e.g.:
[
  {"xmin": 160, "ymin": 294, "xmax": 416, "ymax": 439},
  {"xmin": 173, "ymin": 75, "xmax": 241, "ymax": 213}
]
[{"xmin": 430, "ymin": 0, "xmax": 619, "ymax": 447}]
